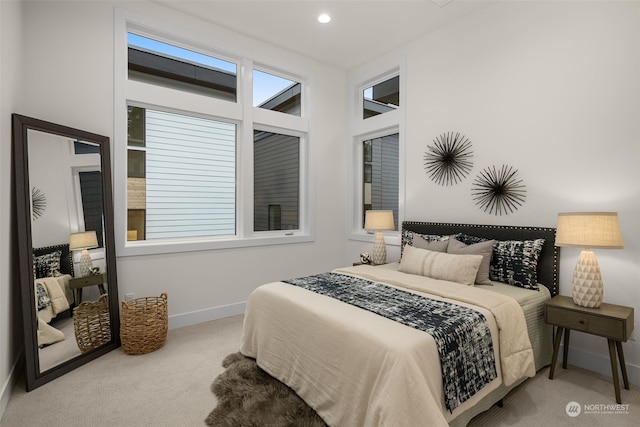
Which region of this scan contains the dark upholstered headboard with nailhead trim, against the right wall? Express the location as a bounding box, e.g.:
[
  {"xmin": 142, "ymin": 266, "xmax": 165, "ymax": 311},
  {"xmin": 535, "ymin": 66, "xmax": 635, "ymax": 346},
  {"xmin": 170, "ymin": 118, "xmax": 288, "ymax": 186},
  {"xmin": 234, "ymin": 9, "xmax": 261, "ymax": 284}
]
[{"xmin": 402, "ymin": 221, "xmax": 560, "ymax": 296}]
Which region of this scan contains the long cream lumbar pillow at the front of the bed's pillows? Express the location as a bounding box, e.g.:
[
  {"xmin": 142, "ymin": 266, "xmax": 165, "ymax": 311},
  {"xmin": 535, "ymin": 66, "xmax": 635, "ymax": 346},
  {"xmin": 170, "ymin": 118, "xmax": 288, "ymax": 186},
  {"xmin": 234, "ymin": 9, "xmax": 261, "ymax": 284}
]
[{"xmin": 400, "ymin": 246, "xmax": 482, "ymax": 286}]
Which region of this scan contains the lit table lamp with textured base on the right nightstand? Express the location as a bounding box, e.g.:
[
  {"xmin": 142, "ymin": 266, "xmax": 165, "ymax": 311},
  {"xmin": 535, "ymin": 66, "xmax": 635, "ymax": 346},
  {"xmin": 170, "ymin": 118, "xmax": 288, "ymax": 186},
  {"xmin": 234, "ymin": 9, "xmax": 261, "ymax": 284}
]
[{"xmin": 555, "ymin": 212, "xmax": 623, "ymax": 308}]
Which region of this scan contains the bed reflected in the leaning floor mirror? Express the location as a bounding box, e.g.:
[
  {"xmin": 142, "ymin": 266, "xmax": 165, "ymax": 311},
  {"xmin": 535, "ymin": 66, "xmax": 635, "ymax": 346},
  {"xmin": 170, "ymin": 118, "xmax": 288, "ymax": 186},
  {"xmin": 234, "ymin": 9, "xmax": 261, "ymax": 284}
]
[{"xmin": 33, "ymin": 244, "xmax": 74, "ymax": 347}]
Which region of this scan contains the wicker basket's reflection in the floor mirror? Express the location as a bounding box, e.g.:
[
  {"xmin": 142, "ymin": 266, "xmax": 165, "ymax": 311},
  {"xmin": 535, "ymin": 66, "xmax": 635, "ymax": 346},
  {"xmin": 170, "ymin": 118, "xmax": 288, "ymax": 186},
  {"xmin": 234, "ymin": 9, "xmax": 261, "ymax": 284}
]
[{"xmin": 73, "ymin": 294, "xmax": 111, "ymax": 353}]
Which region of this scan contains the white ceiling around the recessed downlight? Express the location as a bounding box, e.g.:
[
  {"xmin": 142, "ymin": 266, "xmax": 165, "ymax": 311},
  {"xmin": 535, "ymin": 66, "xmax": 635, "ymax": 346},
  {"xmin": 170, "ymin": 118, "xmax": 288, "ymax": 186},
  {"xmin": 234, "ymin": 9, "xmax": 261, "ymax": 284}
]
[{"xmin": 158, "ymin": 0, "xmax": 495, "ymax": 70}]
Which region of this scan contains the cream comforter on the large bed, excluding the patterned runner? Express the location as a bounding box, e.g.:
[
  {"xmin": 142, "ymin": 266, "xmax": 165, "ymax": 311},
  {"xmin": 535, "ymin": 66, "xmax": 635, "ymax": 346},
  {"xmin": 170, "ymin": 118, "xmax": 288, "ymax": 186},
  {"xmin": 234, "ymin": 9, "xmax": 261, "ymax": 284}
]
[{"xmin": 241, "ymin": 266, "xmax": 535, "ymax": 427}]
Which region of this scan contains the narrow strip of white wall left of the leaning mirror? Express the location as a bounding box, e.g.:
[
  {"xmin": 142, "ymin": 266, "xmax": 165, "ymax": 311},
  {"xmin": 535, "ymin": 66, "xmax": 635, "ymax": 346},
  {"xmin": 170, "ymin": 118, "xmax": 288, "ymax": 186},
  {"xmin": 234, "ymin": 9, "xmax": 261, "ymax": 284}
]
[{"xmin": 0, "ymin": 1, "xmax": 22, "ymax": 416}]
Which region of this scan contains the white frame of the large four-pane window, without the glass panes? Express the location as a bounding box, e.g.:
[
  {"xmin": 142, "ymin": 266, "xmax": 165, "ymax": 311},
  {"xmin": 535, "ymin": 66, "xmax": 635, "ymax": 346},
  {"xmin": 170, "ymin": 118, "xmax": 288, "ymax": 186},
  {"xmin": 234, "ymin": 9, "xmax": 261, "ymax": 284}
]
[{"xmin": 113, "ymin": 9, "xmax": 315, "ymax": 256}]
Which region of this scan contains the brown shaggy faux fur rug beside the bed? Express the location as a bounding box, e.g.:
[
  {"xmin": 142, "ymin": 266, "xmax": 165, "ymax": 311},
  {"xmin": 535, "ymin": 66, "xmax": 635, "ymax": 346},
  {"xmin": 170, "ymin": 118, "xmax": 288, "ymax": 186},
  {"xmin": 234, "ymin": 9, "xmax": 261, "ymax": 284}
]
[{"xmin": 205, "ymin": 353, "xmax": 326, "ymax": 427}]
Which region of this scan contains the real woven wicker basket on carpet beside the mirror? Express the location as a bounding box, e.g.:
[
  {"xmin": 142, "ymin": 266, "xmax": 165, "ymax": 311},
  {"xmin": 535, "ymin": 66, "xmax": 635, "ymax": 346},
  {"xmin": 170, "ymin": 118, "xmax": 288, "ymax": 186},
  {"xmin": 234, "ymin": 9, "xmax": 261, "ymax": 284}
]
[{"xmin": 120, "ymin": 293, "xmax": 168, "ymax": 354}]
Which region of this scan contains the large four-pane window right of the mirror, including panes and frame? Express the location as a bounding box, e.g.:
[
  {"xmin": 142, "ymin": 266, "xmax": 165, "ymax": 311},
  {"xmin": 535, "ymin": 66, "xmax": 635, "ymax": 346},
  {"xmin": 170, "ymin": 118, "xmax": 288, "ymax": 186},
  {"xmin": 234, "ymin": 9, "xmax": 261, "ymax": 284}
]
[{"xmin": 120, "ymin": 18, "xmax": 313, "ymax": 256}]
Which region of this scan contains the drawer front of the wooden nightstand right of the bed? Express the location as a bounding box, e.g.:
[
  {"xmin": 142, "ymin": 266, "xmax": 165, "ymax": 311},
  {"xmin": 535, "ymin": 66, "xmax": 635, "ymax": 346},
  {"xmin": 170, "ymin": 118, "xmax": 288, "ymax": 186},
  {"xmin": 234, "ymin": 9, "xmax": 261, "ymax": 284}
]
[{"xmin": 546, "ymin": 307, "xmax": 627, "ymax": 341}]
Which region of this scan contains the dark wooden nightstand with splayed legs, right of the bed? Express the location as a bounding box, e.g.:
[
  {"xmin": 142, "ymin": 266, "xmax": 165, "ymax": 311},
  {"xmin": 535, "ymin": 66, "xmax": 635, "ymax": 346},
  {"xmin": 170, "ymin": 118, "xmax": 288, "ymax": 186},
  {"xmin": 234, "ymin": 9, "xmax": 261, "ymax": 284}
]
[{"xmin": 545, "ymin": 295, "xmax": 633, "ymax": 403}]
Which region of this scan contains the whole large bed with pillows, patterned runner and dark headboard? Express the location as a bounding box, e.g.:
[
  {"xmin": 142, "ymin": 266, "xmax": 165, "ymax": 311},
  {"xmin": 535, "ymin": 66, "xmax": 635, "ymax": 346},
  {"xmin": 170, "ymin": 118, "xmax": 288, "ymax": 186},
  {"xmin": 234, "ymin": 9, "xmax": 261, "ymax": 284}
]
[{"xmin": 240, "ymin": 221, "xmax": 558, "ymax": 426}]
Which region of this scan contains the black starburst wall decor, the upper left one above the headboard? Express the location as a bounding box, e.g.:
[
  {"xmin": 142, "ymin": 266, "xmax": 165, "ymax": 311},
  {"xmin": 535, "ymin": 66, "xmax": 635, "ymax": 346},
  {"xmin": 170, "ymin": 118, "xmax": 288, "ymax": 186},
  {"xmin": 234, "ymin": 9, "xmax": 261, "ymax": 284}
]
[{"xmin": 424, "ymin": 132, "xmax": 473, "ymax": 185}]
